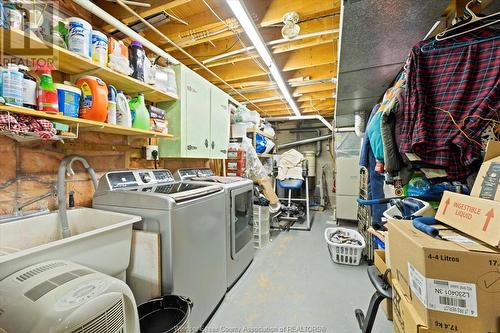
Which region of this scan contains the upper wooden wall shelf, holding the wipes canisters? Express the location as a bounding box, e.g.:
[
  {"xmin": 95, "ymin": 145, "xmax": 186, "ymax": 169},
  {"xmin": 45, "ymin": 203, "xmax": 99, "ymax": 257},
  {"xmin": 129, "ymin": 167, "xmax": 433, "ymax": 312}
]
[{"xmin": 0, "ymin": 29, "xmax": 178, "ymax": 103}]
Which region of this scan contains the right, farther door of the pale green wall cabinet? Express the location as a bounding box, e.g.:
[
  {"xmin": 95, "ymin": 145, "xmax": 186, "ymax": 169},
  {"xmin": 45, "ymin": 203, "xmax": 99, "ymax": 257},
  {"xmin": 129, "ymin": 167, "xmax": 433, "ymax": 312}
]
[{"xmin": 210, "ymin": 86, "xmax": 230, "ymax": 159}]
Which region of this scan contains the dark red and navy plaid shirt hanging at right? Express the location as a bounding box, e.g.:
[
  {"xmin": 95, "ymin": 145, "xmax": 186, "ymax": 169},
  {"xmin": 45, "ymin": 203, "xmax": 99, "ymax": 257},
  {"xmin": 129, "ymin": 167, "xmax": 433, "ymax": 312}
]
[{"xmin": 397, "ymin": 28, "xmax": 500, "ymax": 179}]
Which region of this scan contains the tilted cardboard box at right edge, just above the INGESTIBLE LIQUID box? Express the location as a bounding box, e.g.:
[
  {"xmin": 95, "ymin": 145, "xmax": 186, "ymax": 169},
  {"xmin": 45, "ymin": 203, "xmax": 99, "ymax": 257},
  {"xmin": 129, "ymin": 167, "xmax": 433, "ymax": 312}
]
[{"xmin": 471, "ymin": 141, "xmax": 500, "ymax": 201}]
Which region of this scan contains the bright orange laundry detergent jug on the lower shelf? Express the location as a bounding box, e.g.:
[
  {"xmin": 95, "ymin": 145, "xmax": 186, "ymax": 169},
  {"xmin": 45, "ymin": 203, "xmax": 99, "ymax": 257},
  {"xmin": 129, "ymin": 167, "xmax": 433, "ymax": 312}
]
[{"xmin": 76, "ymin": 76, "xmax": 108, "ymax": 122}]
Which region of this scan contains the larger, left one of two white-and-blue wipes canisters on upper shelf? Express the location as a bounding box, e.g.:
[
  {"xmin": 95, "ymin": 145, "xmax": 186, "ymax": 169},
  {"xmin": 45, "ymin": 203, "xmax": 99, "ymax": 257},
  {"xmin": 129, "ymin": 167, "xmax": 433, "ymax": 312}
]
[{"xmin": 67, "ymin": 17, "xmax": 92, "ymax": 58}]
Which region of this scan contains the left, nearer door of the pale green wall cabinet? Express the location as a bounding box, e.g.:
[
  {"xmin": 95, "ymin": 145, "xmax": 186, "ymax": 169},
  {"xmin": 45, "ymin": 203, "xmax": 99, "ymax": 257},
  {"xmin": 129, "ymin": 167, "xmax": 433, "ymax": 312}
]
[{"xmin": 185, "ymin": 70, "xmax": 211, "ymax": 158}]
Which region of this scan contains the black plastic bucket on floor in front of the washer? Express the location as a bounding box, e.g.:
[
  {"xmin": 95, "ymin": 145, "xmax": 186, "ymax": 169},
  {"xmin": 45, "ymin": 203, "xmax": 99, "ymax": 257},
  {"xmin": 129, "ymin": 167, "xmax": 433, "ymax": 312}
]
[{"xmin": 137, "ymin": 295, "xmax": 193, "ymax": 333}]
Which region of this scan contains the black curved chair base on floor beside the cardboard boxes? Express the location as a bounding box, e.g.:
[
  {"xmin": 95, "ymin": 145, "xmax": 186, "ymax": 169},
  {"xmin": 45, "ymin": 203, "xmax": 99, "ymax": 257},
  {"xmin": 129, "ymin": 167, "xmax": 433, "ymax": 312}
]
[{"xmin": 354, "ymin": 266, "xmax": 392, "ymax": 333}]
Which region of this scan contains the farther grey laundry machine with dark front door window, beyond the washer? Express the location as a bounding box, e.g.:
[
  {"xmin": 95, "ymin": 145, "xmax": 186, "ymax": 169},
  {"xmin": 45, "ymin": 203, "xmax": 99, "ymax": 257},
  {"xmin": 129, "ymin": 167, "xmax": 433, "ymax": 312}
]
[{"xmin": 174, "ymin": 168, "xmax": 255, "ymax": 290}]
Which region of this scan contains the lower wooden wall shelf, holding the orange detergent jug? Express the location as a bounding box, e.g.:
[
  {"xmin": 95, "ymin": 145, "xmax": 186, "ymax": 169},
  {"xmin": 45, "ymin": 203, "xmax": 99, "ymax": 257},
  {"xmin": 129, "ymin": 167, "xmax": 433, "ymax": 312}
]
[{"xmin": 0, "ymin": 105, "xmax": 174, "ymax": 138}]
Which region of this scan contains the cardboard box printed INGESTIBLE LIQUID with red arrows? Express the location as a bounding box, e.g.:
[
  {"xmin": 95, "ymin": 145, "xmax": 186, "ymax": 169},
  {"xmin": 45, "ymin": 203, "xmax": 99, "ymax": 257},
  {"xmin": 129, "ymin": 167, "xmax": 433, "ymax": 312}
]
[{"xmin": 436, "ymin": 191, "xmax": 500, "ymax": 247}]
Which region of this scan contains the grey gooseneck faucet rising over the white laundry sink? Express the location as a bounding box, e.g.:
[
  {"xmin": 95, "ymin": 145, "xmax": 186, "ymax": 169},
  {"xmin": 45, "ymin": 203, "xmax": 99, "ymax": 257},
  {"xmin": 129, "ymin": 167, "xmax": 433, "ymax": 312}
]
[{"xmin": 57, "ymin": 155, "xmax": 97, "ymax": 238}]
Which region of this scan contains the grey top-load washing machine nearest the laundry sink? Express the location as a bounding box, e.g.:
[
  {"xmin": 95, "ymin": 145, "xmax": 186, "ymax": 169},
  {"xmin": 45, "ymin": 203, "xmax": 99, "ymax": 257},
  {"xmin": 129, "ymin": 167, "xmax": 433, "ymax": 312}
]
[{"xmin": 93, "ymin": 170, "xmax": 227, "ymax": 329}]
